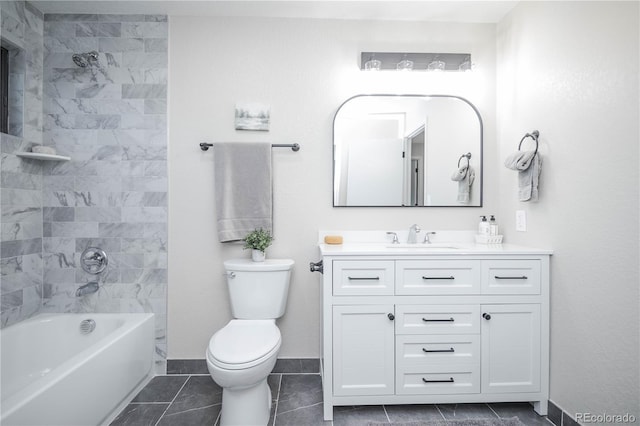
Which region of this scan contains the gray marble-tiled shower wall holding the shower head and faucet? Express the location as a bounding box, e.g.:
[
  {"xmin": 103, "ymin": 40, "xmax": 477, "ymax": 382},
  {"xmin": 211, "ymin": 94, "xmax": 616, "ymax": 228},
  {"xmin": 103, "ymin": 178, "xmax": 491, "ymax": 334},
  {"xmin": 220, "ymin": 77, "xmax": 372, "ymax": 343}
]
[{"xmin": 42, "ymin": 14, "xmax": 168, "ymax": 373}]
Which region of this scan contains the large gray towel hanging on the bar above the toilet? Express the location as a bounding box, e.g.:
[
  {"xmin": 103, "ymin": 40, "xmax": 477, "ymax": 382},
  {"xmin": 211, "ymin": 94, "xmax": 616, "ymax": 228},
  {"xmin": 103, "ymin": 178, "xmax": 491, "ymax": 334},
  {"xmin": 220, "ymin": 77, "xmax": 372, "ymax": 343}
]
[{"xmin": 213, "ymin": 142, "xmax": 273, "ymax": 242}]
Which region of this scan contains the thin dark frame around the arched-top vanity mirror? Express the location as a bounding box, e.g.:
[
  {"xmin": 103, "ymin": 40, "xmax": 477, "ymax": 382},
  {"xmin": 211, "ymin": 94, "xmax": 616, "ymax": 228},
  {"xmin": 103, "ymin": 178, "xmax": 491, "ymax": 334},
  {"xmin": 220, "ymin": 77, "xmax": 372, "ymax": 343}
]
[{"xmin": 331, "ymin": 93, "xmax": 484, "ymax": 208}]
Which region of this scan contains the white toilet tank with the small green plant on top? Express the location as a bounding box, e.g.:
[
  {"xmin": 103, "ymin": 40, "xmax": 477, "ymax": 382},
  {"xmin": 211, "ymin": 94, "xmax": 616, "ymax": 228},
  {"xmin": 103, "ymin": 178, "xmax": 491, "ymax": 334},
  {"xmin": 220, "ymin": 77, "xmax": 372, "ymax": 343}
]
[{"xmin": 224, "ymin": 259, "xmax": 294, "ymax": 319}]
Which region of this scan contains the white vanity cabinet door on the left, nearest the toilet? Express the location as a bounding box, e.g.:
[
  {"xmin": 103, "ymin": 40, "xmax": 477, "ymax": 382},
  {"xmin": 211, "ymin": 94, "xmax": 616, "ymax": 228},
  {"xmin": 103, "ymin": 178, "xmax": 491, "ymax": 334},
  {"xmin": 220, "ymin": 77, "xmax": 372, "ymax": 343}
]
[{"xmin": 333, "ymin": 305, "xmax": 395, "ymax": 396}]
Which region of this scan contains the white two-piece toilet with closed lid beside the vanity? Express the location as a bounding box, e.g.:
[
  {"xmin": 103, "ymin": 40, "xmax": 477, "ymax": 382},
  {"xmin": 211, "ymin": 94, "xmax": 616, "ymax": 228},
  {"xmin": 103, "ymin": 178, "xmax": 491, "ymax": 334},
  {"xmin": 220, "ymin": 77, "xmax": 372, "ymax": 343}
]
[{"xmin": 207, "ymin": 259, "xmax": 294, "ymax": 426}]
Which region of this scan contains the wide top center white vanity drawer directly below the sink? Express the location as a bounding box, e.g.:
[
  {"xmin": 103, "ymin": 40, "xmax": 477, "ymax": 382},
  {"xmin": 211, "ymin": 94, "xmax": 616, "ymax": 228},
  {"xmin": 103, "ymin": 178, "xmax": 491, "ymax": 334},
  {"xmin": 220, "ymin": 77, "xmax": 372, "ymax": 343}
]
[{"xmin": 396, "ymin": 260, "xmax": 480, "ymax": 295}]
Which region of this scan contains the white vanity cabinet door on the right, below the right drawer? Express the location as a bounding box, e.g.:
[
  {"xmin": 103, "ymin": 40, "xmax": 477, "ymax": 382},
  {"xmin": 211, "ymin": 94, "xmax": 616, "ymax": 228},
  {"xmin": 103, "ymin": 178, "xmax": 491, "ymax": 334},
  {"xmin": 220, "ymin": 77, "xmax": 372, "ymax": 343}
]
[{"xmin": 481, "ymin": 304, "xmax": 541, "ymax": 393}]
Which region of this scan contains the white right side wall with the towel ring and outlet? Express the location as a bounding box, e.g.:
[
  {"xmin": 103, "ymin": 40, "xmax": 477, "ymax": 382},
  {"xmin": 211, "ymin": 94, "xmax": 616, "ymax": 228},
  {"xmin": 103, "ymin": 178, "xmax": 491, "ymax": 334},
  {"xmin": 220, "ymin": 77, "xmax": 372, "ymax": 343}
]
[{"xmin": 497, "ymin": 2, "xmax": 640, "ymax": 418}]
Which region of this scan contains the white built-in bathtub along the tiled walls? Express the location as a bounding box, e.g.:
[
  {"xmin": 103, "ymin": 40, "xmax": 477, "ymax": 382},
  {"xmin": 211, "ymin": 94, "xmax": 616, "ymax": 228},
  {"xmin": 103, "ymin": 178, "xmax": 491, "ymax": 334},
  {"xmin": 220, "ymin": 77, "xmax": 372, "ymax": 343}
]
[{"xmin": 0, "ymin": 314, "xmax": 154, "ymax": 426}]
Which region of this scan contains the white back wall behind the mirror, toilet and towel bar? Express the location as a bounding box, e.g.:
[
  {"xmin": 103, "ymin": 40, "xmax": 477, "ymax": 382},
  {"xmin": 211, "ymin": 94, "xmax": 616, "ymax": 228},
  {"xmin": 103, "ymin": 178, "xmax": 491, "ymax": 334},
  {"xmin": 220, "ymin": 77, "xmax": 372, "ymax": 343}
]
[{"xmin": 168, "ymin": 17, "xmax": 498, "ymax": 359}]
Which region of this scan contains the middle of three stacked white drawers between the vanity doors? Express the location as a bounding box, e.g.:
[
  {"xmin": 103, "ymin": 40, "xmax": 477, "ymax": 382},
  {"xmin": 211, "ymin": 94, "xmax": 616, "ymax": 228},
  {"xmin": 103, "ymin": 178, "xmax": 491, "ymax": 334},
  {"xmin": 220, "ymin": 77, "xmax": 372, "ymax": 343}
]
[{"xmin": 396, "ymin": 334, "xmax": 480, "ymax": 366}]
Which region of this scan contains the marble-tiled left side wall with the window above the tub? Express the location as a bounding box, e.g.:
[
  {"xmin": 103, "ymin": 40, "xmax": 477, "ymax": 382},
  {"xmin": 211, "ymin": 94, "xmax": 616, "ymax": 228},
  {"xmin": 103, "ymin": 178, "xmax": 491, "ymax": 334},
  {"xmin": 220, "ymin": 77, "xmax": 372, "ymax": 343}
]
[{"xmin": 0, "ymin": 1, "xmax": 43, "ymax": 327}]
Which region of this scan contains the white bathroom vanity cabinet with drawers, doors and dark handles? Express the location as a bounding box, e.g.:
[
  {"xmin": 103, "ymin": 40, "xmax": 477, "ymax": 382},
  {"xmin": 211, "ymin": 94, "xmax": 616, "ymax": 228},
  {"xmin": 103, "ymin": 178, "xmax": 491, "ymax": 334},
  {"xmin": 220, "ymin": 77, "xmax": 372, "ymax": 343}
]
[{"xmin": 321, "ymin": 245, "xmax": 550, "ymax": 420}]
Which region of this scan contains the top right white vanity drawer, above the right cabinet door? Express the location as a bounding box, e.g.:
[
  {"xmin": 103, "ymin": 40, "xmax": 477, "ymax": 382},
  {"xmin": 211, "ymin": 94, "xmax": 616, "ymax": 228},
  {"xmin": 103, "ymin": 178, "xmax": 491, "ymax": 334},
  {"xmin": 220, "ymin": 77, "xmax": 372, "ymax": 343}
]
[{"xmin": 482, "ymin": 259, "xmax": 541, "ymax": 294}]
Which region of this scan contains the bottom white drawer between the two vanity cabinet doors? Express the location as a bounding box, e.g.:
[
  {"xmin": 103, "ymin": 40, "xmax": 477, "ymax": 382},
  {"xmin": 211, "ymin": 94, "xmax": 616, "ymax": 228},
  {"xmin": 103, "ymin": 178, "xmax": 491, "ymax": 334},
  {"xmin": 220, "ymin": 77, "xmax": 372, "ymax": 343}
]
[{"xmin": 396, "ymin": 364, "xmax": 480, "ymax": 395}]
